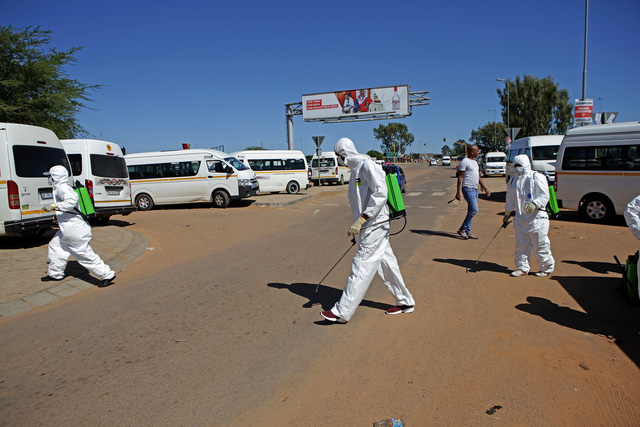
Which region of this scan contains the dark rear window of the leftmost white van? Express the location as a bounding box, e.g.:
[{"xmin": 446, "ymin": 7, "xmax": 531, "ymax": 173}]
[{"xmin": 13, "ymin": 145, "xmax": 69, "ymax": 178}]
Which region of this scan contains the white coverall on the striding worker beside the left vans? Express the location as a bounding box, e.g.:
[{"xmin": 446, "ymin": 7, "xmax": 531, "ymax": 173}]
[{"xmin": 47, "ymin": 166, "xmax": 115, "ymax": 280}]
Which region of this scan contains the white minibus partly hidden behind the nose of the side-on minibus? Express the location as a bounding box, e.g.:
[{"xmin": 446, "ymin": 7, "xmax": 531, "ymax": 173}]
[{"xmin": 231, "ymin": 150, "xmax": 311, "ymax": 194}]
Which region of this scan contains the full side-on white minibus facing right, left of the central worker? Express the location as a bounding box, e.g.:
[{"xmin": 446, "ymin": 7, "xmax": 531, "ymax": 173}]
[{"xmin": 124, "ymin": 148, "xmax": 258, "ymax": 211}]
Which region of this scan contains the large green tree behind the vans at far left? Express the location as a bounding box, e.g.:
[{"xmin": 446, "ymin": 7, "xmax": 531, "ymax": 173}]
[{"xmin": 0, "ymin": 26, "xmax": 100, "ymax": 139}]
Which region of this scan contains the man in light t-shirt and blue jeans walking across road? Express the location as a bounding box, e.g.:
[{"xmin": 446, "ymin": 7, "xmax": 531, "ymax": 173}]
[{"xmin": 456, "ymin": 145, "xmax": 491, "ymax": 240}]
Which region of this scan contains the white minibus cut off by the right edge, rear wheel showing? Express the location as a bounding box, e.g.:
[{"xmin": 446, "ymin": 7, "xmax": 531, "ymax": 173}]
[{"xmin": 555, "ymin": 122, "xmax": 640, "ymax": 222}]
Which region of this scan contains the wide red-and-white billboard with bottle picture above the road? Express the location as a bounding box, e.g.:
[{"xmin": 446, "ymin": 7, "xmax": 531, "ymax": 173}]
[{"xmin": 302, "ymin": 85, "xmax": 411, "ymax": 121}]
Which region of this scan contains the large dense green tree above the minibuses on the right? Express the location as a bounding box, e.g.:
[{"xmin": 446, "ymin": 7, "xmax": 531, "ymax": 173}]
[{"xmin": 498, "ymin": 74, "xmax": 573, "ymax": 137}]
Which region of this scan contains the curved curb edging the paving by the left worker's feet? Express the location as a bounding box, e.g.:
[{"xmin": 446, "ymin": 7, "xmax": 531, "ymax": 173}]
[{"xmin": 0, "ymin": 229, "xmax": 149, "ymax": 319}]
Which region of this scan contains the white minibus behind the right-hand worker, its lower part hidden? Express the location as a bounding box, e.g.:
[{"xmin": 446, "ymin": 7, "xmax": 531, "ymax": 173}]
[{"xmin": 507, "ymin": 135, "xmax": 564, "ymax": 183}]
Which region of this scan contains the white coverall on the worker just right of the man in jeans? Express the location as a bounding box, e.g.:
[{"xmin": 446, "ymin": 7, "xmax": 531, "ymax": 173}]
[{"xmin": 504, "ymin": 154, "xmax": 555, "ymax": 274}]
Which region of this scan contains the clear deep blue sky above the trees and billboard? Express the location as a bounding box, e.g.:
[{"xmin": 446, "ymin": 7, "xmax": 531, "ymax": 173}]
[{"xmin": 0, "ymin": 0, "xmax": 640, "ymax": 154}]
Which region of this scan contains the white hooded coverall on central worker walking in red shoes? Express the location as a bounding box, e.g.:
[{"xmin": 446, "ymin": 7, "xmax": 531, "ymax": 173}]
[{"xmin": 331, "ymin": 138, "xmax": 415, "ymax": 321}]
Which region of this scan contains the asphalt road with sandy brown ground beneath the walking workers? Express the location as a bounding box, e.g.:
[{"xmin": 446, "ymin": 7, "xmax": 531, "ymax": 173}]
[{"xmin": 0, "ymin": 165, "xmax": 640, "ymax": 425}]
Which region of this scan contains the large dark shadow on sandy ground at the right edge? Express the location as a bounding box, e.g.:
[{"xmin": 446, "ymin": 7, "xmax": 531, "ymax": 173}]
[{"xmin": 516, "ymin": 276, "xmax": 640, "ymax": 367}]
